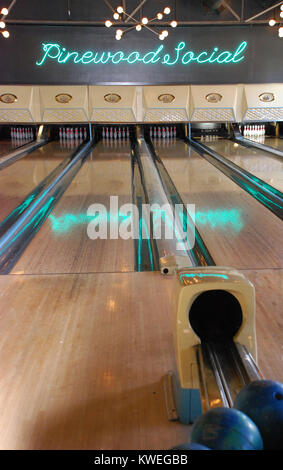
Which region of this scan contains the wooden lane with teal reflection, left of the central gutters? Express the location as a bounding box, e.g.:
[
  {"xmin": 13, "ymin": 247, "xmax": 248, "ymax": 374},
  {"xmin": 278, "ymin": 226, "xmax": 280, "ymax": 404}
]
[{"xmin": 12, "ymin": 141, "xmax": 134, "ymax": 274}]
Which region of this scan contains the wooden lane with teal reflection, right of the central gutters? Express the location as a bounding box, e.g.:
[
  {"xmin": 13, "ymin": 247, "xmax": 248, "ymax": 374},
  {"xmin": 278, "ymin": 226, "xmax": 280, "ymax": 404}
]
[{"xmin": 155, "ymin": 140, "xmax": 283, "ymax": 269}]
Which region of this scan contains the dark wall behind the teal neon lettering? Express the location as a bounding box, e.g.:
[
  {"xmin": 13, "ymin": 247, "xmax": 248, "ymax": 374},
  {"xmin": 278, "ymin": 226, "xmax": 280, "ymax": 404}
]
[{"xmin": 0, "ymin": 25, "xmax": 283, "ymax": 84}]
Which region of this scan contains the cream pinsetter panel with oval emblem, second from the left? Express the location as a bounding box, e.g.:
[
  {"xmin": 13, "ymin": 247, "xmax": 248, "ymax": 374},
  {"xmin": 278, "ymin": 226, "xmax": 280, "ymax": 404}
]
[{"xmin": 39, "ymin": 85, "xmax": 88, "ymax": 122}]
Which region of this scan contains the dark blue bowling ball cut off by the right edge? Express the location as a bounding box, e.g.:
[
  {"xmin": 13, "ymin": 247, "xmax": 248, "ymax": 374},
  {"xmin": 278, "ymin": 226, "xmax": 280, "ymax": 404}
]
[{"xmin": 234, "ymin": 380, "xmax": 283, "ymax": 450}]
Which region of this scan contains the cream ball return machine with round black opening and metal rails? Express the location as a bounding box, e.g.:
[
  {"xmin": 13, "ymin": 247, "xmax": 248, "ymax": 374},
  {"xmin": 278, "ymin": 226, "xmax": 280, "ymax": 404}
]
[{"xmin": 165, "ymin": 266, "xmax": 263, "ymax": 424}]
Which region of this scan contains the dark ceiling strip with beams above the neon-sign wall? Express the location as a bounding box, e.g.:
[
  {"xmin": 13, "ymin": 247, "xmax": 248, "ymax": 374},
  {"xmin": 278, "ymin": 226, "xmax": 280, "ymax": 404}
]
[{"xmin": 0, "ymin": 0, "xmax": 279, "ymax": 24}]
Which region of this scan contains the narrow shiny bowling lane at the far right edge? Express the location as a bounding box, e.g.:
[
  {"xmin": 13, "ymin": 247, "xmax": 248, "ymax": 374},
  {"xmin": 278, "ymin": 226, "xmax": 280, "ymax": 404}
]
[{"xmin": 204, "ymin": 139, "xmax": 283, "ymax": 191}]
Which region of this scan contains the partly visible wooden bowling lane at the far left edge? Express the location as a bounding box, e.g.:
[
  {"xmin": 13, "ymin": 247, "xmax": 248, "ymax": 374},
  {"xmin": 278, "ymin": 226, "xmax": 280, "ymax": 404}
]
[{"xmin": 0, "ymin": 142, "xmax": 75, "ymax": 222}]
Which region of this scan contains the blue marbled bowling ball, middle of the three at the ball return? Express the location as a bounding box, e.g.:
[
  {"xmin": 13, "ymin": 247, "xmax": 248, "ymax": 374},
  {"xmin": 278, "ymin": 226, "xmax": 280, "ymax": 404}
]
[{"xmin": 191, "ymin": 408, "xmax": 263, "ymax": 450}]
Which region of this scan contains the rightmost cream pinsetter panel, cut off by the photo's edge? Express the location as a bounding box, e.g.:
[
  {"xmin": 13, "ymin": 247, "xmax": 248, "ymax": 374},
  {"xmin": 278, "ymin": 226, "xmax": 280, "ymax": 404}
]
[{"xmin": 243, "ymin": 83, "xmax": 283, "ymax": 122}]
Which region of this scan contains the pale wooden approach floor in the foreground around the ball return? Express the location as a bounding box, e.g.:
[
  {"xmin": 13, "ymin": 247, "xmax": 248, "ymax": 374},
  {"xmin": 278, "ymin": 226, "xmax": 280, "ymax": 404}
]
[{"xmin": 0, "ymin": 269, "xmax": 283, "ymax": 449}]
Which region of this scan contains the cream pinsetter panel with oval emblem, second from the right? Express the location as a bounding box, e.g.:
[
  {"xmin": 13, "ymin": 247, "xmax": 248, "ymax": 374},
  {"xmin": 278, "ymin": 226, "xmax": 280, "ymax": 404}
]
[{"xmin": 190, "ymin": 85, "xmax": 242, "ymax": 122}]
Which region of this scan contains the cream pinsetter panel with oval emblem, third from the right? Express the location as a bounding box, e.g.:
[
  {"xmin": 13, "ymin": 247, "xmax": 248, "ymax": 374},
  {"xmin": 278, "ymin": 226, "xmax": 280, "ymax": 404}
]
[{"xmin": 143, "ymin": 86, "xmax": 190, "ymax": 122}]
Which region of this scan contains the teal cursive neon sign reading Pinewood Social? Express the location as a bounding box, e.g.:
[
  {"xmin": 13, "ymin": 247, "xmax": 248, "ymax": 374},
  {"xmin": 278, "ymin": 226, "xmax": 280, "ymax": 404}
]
[{"xmin": 36, "ymin": 41, "xmax": 248, "ymax": 66}]
